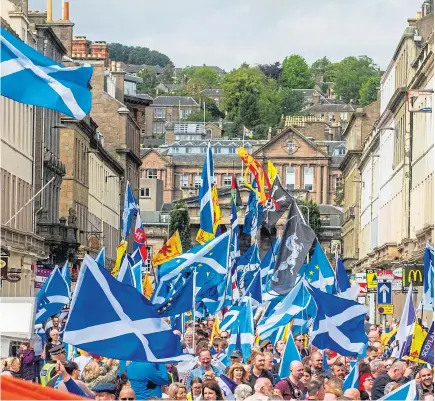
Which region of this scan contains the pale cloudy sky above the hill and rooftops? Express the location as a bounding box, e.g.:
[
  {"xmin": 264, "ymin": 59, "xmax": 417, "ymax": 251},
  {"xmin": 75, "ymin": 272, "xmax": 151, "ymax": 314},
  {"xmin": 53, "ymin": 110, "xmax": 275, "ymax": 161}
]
[{"xmin": 29, "ymin": 0, "xmax": 423, "ymax": 71}]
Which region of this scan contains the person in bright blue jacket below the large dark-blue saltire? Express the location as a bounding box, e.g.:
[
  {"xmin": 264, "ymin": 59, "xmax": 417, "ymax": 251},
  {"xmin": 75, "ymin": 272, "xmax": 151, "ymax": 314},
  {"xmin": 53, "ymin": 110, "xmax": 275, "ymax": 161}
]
[{"xmin": 126, "ymin": 361, "xmax": 169, "ymax": 400}]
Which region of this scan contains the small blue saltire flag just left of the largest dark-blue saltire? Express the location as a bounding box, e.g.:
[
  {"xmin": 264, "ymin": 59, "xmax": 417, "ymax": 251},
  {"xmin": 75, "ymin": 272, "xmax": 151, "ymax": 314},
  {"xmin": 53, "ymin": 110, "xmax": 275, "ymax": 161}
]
[{"xmin": 35, "ymin": 266, "xmax": 69, "ymax": 324}]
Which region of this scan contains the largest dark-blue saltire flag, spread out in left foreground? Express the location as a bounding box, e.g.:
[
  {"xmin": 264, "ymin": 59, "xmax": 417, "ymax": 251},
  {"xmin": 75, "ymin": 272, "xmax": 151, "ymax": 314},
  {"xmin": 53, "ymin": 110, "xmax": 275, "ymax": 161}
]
[{"xmin": 64, "ymin": 255, "xmax": 191, "ymax": 363}]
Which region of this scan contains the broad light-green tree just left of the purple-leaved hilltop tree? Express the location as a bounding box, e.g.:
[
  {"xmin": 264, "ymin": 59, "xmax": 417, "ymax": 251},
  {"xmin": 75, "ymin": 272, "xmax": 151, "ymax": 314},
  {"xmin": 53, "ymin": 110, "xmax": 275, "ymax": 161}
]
[{"xmin": 221, "ymin": 66, "xmax": 266, "ymax": 121}]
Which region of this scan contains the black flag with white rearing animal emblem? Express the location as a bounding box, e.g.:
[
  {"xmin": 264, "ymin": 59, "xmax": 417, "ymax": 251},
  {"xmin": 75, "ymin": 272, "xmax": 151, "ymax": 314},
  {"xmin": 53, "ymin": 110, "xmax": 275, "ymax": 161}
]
[{"xmin": 270, "ymin": 202, "xmax": 316, "ymax": 295}]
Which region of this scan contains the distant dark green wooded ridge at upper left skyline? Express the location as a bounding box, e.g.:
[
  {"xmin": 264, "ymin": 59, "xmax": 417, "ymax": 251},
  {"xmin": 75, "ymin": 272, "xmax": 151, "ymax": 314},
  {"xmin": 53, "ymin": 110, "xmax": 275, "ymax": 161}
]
[{"xmin": 109, "ymin": 43, "xmax": 172, "ymax": 67}]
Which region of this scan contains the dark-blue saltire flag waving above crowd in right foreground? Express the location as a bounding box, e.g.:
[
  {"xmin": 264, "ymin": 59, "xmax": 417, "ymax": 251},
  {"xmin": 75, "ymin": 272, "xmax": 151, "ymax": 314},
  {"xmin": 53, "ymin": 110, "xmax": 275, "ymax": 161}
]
[{"xmin": 308, "ymin": 286, "xmax": 368, "ymax": 356}]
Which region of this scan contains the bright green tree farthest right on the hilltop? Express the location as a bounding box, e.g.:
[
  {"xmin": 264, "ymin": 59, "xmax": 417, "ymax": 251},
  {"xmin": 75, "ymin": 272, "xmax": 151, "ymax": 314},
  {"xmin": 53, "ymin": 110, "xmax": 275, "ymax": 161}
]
[{"xmin": 330, "ymin": 56, "xmax": 379, "ymax": 103}]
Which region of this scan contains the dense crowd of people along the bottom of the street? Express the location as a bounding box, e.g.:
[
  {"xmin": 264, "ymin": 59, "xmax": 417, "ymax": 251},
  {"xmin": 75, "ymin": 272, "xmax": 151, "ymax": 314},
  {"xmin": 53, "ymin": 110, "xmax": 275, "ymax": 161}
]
[{"xmin": 1, "ymin": 317, "xmax": 434, "ymax": 401}]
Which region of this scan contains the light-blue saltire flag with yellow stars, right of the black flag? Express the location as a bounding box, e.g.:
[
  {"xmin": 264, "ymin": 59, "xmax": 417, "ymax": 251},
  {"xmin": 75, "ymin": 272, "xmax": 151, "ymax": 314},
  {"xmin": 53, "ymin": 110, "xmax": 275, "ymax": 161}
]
[{"xmin": 299, "ymin": 241, "xmax": 336, "ymax": 294}]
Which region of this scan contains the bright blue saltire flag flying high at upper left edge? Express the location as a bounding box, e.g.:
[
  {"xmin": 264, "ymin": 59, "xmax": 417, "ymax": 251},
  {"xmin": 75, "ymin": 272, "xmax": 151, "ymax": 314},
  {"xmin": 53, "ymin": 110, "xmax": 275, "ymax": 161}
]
[{"xmin": 0, "ymin": 28, "xmax": 92, "ymax": 120}]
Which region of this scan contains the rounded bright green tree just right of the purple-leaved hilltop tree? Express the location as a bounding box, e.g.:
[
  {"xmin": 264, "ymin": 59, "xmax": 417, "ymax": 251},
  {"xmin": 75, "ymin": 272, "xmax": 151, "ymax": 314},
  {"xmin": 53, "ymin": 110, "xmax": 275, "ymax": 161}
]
[{"xmin": 282, "ymin": 54, "xmax": 314, "ymax": 89}]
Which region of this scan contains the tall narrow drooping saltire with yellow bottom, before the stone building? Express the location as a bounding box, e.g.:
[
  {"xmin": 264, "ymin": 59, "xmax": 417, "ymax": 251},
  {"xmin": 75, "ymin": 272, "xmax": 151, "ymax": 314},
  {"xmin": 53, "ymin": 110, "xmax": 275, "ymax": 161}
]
[{"xmin": 196, "ymin": 143, "xmax": 214, "ymax": 244}]
